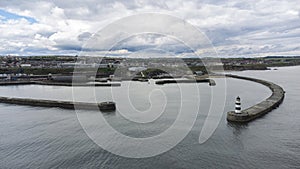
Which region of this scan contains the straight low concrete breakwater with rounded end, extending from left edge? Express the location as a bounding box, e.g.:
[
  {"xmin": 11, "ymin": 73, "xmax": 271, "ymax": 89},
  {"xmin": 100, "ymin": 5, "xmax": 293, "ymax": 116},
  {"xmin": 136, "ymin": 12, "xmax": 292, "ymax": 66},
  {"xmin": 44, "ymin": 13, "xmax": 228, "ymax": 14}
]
[{"xmin": 0, "ymin": 97, "xmax": 115, "ymax": 111}]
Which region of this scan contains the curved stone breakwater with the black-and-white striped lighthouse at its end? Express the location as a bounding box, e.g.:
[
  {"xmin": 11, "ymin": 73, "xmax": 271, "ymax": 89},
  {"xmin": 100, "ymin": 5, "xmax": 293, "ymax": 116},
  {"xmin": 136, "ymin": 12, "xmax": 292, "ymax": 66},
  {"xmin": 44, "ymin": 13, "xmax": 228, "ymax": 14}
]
[{"xmin": 225, "ymin": 74, "xmax": 285, "ymax": 123}]
